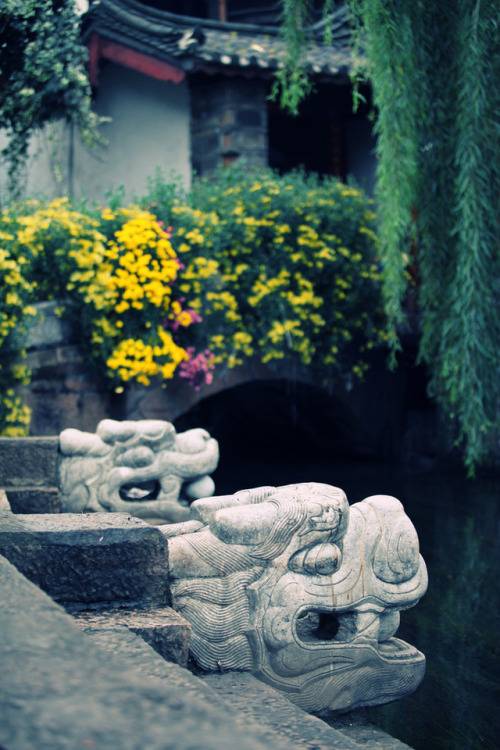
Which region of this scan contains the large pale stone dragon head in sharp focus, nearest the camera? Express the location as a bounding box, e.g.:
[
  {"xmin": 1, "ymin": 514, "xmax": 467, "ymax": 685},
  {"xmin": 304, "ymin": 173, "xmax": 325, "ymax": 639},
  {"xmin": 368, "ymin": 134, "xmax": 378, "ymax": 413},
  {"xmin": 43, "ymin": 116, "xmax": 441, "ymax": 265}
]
[{"xmin": 160, "ymin": 483, "xmax": 427, "ymax": 713}]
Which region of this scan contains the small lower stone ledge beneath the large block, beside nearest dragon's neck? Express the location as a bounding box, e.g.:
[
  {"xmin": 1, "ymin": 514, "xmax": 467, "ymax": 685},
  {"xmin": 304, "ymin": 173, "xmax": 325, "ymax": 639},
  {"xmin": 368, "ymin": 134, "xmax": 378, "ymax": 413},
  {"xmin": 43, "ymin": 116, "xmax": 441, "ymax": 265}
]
[{"xmin": 74, "ymin": 607, "xmax": 191, "ymax": 667}]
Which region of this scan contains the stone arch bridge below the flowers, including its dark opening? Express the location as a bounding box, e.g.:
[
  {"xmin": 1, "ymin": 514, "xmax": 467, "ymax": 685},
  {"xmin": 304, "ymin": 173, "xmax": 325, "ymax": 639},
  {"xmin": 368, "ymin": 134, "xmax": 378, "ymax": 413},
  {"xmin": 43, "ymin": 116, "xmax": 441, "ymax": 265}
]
[{"xmin": 19, "ymin": 303, "xmax": 436, "ymax": 472}]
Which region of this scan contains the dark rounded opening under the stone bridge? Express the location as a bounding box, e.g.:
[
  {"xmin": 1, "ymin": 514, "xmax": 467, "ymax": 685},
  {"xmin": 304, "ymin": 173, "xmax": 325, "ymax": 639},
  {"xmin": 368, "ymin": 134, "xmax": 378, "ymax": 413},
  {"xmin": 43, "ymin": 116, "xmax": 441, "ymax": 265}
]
[{"xmin": 174, "ymin": 379, "xmax": 373, "ymax": 494}]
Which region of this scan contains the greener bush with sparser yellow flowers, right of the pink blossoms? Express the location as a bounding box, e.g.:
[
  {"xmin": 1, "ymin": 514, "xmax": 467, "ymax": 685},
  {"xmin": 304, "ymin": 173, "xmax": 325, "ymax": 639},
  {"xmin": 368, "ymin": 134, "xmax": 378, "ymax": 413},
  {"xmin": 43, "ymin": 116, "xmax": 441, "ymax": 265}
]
[{"xmin": 169, "ymin": 169, "xmax": 386, "ymax": 382}]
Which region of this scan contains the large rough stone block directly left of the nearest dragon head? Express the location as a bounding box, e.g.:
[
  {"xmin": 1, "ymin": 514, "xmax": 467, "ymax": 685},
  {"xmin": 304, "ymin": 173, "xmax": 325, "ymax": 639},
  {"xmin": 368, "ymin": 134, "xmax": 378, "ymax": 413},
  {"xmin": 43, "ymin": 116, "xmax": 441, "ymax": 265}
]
[{"xmin": 0, "ymin": 511, "xmax": 168, "ymax": 605}]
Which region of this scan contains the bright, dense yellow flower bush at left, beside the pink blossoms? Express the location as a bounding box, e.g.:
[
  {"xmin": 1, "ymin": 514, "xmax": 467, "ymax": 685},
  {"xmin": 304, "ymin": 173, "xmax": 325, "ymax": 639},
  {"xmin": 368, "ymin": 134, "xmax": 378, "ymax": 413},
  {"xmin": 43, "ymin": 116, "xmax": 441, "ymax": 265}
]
[{"xmin": 0, "ymin": 199, "xmax": 208, "ymax": 434}]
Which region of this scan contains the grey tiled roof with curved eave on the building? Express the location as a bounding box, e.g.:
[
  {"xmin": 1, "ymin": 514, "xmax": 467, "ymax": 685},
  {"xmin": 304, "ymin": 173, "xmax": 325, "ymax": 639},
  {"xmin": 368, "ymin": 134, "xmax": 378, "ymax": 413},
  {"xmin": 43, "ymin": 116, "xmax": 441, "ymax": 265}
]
[{"xmin": 84, "ymin": 0, "xmax": 352, "ymax": 76}]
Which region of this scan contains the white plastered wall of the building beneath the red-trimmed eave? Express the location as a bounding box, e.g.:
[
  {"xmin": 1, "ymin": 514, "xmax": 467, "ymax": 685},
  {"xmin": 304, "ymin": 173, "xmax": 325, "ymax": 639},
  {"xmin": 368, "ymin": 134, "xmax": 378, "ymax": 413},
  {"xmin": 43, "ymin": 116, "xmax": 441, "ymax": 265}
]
[{"xmin": 0, "ymin": 63, "xmax": 191, "ymax": 202}]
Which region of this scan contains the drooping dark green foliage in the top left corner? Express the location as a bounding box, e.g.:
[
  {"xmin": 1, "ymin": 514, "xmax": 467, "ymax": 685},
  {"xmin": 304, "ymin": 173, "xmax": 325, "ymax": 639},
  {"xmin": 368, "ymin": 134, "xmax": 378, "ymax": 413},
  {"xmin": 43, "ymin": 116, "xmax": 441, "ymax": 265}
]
[{"xmin": 0, "ymin": 0, "xmax": 103, "ymax": 200}]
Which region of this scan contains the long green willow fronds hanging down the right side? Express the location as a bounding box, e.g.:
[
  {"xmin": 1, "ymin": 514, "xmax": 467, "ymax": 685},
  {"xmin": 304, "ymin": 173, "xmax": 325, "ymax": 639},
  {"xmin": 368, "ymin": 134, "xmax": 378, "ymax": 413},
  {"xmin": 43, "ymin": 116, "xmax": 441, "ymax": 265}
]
[{"xmin": 278, "ymin": 0, "xmax": 500, "ymax": 475}]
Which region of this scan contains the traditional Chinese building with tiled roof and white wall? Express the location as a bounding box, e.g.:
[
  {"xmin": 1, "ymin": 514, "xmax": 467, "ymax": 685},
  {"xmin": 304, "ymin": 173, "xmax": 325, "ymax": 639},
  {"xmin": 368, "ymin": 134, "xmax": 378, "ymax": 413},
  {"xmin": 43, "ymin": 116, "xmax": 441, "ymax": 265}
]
[{"xmin": 8, "ymin": 0, "xmax": 374, "ymax": 199}]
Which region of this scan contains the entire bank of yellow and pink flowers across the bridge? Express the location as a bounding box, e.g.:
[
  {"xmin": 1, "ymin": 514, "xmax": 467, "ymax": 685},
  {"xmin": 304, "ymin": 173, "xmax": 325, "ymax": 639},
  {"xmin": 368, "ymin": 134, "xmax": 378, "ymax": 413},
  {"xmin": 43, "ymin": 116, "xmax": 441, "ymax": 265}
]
[{"xmin": 0, "ymin": 168, "xmax": 385, "ymax": 434}]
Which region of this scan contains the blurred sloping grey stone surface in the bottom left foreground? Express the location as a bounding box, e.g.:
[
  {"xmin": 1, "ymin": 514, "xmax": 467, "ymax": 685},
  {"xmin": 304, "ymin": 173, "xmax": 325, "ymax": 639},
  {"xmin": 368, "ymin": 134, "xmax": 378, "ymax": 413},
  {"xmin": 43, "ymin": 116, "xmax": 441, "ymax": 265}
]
[{"xmin": 0, "ymin": 558, "xmax": 366, "ymax": 750}]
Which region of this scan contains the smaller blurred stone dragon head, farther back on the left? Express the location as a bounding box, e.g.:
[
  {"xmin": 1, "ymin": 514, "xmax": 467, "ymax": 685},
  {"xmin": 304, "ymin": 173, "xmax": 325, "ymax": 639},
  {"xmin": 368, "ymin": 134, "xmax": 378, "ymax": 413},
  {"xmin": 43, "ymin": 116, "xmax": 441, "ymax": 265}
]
[{"xmin": 59, "ymin": 419, "xmax": 219, "ymax": 523}]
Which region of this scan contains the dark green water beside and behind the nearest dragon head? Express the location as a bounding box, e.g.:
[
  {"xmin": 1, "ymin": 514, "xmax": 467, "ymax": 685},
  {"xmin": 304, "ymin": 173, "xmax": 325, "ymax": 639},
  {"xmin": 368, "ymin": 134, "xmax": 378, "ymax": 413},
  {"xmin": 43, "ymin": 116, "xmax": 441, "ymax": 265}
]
[{"xmin": 216, "ymin": 460, "xmax": 500, "ymax": 750}]
